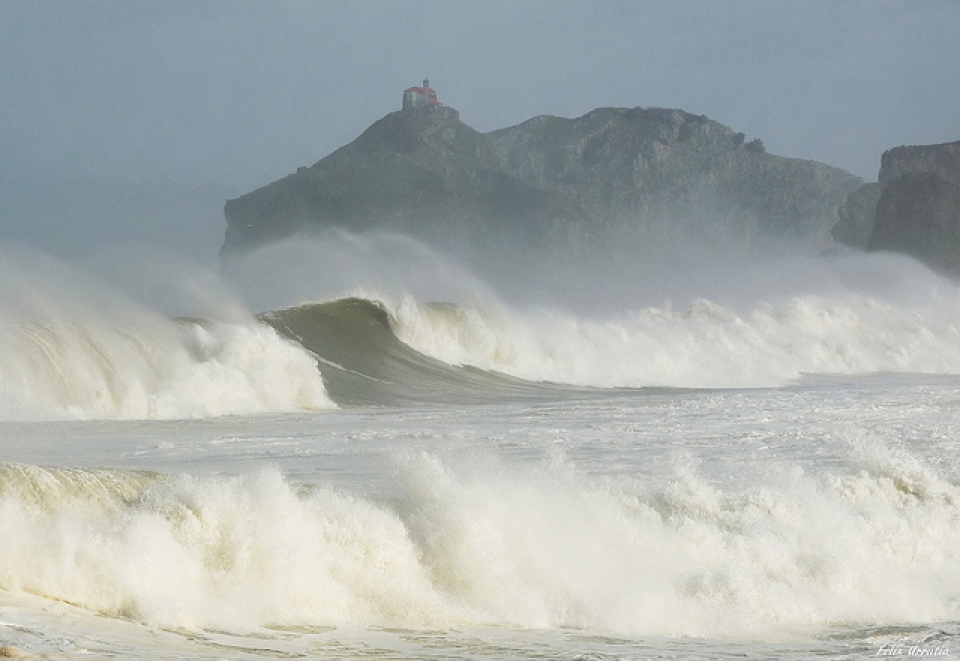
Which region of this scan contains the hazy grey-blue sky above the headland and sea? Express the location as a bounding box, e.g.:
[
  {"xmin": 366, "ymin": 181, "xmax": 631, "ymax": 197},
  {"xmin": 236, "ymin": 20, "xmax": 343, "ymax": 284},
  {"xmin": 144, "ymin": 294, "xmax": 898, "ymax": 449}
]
[{"xmin": 0, "ymin": 0, "xmax": 960, "ymax": 263}]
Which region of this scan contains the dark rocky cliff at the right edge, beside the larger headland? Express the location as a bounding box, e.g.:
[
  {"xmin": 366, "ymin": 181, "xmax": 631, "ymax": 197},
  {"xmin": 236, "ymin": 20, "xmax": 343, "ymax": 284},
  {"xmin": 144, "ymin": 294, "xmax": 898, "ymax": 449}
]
[{"xmin": 833, "ymin": 142, "xmax": 960, "ymax": 273}]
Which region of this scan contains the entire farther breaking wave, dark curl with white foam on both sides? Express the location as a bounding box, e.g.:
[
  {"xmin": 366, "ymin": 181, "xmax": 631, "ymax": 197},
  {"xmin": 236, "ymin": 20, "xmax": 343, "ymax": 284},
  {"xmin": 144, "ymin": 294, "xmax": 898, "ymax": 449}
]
[{"xmin": 0, "ymin": 240, "xmax": 960, "ymax": 420}]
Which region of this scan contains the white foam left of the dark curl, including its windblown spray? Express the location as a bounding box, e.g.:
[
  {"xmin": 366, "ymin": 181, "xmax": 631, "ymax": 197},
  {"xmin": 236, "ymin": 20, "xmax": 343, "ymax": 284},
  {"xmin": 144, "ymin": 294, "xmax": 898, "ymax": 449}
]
[{"xmin": 0, "ymin": 245, "xmax": 332, "ymax": 420}]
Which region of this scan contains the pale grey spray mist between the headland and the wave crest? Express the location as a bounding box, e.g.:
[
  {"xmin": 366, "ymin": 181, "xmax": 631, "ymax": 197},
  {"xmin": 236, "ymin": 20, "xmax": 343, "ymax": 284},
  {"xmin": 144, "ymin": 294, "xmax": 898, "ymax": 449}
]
[{"xmin": 224, "ymin": 220, "xmax": 958, "ymax": 318}]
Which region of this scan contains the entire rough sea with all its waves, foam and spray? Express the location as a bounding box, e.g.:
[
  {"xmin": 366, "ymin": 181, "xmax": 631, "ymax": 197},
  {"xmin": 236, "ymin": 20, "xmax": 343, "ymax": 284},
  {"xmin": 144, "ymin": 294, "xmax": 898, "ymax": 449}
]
[{"xmin": 0, "ymin": 233, "xmax": 960, "ymax": 661}]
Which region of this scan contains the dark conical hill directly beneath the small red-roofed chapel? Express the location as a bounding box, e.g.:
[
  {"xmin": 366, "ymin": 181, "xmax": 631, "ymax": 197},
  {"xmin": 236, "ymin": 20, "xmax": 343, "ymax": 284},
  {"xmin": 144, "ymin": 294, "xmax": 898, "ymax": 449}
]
[{"xmin": 224, "ymin": 106, "xmax": 584, "ymax": 250}]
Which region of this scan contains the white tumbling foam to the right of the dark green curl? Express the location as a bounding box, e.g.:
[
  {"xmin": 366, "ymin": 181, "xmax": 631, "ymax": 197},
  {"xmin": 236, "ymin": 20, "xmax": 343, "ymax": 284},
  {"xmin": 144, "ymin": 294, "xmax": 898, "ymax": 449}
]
[{"xmin": 385, "ymin": 295, "xmax": 960, "ymax": 387}]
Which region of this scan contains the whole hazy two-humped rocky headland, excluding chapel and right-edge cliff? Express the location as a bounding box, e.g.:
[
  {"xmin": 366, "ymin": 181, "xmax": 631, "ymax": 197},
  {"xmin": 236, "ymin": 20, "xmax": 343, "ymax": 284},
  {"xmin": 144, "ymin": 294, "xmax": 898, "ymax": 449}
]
[{"xmin": 224, "ymin": 107, "xmax": 860, "ymax": 251}]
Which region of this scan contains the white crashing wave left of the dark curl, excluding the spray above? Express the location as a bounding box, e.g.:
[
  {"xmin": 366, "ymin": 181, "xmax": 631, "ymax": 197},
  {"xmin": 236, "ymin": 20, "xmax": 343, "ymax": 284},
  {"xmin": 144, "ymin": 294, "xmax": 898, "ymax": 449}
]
[{"xmin": 0, "ymin": 319, "xmax": 332, "ymax": 419}]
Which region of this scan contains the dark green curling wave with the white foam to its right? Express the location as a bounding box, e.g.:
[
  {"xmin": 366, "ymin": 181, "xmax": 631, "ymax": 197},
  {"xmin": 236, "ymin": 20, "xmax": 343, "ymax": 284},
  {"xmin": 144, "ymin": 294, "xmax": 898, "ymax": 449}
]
[{"xmin": 262, "ymin": 282, "xmax": 960, "ymax": 404}]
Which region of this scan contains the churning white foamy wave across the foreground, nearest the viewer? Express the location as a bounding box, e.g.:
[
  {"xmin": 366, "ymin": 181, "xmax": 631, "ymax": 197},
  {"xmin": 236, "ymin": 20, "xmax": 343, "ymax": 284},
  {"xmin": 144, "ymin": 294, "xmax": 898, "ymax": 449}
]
[{"xmin": 0, "ymin": 455, "xmax": 960, "ymax": 637}]
